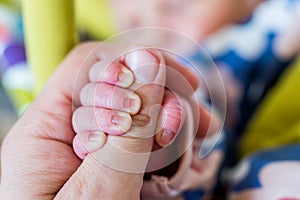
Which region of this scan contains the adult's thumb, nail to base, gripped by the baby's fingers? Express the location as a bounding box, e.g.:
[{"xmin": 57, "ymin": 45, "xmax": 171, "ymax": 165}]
[{"xmin": 57, "ymin": 46, "xmax": 166, "ymax": 199}]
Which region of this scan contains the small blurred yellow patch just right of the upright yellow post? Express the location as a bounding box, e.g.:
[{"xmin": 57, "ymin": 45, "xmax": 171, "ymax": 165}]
[{"xmin": 75, "ymin": 0, "xmax": 116, "ymax": 40}]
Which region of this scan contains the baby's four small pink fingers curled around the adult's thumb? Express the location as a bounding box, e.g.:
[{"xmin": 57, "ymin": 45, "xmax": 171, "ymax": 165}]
[{"xmin": 72, "ymin": 48, "xmax": 141, "ymax": 159}]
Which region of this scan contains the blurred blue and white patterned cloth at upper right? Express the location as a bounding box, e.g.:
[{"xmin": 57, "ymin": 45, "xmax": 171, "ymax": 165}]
[{"xmin": 190, "ymin": 0, "xmax": 300, "ymax": 136}]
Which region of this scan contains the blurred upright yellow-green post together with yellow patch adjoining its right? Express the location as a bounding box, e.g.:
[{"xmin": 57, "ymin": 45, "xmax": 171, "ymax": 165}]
[{"xmin": 22, "ymin": 0, "xmax": 115, "ymax": 94}]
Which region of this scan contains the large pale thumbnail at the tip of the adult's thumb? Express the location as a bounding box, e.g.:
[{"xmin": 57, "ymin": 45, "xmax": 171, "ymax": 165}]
[{"xmin": 125, "ymin": 50, "xmax": 159, "ymax": 83}]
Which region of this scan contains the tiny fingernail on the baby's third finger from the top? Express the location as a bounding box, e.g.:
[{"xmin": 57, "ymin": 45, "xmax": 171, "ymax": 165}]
[{"xmin": 111, "ymin": 112, "xmax": 132, "ymax": 133}]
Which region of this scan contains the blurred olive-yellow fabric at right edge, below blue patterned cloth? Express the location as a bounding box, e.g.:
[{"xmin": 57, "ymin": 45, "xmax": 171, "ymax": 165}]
[{"xmin": 240, "ymin": 58, "xmax": 300, "ymax": 156}]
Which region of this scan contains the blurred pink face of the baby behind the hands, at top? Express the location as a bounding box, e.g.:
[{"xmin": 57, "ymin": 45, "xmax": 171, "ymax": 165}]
[{"xmin": 110, "ymin": 0, "xmax": 262, "ymax": 43}]
